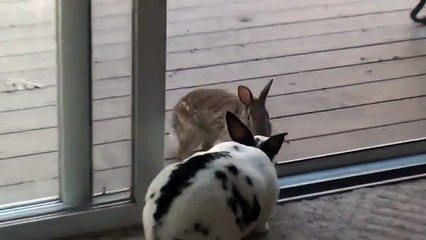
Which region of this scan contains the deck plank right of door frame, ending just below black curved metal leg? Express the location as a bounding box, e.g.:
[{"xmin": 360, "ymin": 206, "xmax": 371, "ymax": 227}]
[{"xmin": 167, "ymin": 25, "xmax": 426, "ymax": 70}]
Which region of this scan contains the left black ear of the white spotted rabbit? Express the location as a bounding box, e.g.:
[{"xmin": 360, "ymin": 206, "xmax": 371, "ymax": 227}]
[{"xmin": 226, "ymin": 112, "xmax": 256, "ymax": 147}]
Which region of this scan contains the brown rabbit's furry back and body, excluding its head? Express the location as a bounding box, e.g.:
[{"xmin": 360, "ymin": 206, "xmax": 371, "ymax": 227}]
[{"xmin": 172, "ymin": 89, "xmax": 246, "ymax": 160}]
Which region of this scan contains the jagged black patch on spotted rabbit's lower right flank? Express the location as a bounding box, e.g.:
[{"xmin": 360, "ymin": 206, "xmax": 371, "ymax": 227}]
[{"xmin": 232, "ymin": 185, "xmax": 260, "ymax": 229}]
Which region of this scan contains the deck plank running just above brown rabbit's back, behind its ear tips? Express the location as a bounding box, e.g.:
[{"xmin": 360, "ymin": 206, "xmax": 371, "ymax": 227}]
[{"xmin": 0, "ymin": 57, "xmax": 426, "ymax": 112}]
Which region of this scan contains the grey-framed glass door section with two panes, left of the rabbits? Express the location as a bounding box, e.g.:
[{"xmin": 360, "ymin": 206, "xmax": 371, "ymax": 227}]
[{"xmin": 0, "ymin": 0, "xmax": 166, "ymax": 239}]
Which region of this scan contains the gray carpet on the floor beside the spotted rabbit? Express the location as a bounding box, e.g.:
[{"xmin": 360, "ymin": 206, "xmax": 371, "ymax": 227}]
[{"xmin": 63, "ymin": 179, "xmax": 426, "ymax": 240}]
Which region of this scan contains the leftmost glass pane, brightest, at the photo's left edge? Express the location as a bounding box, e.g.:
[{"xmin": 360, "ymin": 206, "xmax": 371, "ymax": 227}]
[{"xmin": 0, "ymin": 0, "xmax": 59, "ymax": 208}]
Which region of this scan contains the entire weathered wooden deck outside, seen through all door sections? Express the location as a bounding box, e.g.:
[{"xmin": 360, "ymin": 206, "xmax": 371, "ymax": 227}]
[{"xmin": 0, "ymin": 0, "xmax": 426, "ymax": 205}]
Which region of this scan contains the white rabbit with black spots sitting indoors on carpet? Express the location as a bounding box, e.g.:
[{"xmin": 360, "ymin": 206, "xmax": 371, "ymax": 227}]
[{"xmin": 143, "ymin": 112, "xmax": 287, "ymax": 240}]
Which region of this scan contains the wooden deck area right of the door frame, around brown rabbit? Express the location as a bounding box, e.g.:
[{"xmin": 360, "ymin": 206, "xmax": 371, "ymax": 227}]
[{"xmin": 165, "ymin": 0, "xmax": 426, "ymax": 165}]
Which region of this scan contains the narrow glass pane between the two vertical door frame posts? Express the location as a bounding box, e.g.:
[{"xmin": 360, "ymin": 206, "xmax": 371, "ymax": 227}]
[{"xmin": 92, "ymin": 0, "xmax": 132, "ymax": 199}]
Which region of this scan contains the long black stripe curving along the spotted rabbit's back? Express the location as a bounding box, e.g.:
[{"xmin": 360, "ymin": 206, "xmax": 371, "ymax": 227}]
[{"xmin": 154, "ymin": 151, "xmax": 231, "ymax": 221}]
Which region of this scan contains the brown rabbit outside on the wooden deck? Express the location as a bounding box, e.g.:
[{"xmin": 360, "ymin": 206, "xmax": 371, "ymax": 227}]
[{"xmin": 172, "ymin": 79, "xmax": 273, "ymax": 160}]
